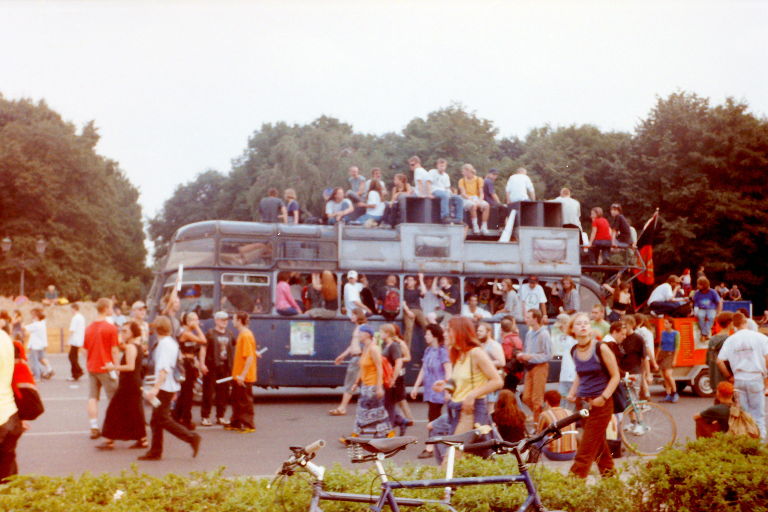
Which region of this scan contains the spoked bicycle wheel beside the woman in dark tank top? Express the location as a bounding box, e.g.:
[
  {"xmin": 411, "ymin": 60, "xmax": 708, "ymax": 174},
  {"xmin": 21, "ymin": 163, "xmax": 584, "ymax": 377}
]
[{"xmin": 619, "ymin": 402, "xmax": 677, "ymax": 455}]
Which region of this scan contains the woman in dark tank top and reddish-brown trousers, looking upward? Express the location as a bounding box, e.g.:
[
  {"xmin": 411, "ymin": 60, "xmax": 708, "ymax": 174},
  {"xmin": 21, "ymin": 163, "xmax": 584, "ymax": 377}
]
[{"xmin": 568, "ymin": 313, "xmax": 619, "ymax": 478}]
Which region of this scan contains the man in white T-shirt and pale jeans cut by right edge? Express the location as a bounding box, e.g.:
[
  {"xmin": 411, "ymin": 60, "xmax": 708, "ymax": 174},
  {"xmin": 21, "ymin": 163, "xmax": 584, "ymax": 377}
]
[{"xmin": 717, "ymin": 313, "xmax": 768, "ymax": 439}]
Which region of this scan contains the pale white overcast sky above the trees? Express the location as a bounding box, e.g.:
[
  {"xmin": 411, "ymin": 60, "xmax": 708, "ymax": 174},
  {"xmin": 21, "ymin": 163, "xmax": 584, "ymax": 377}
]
[{"xmin": 0, "ymin": 0, "xmax": 768, "ymax": 221}]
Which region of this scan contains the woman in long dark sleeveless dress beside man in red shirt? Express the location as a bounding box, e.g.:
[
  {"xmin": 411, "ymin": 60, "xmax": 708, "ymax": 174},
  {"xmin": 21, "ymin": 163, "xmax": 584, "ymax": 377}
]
[{"xmin": 96, "ymin": 321, "xmax": 148, "ymax": 450}]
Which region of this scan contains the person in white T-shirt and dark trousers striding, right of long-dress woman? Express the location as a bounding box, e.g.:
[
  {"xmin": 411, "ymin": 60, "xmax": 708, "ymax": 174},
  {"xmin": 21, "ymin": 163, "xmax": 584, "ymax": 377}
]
[{"xmin": 139, "ymin": 316, "xmax": 200, "ymax": 460}]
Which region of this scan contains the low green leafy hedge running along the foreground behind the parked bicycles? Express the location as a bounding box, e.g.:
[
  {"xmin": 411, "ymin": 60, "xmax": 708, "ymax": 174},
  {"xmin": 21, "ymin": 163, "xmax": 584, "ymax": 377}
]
[{"xmin": 0, "ymin": 436, "xmax": 768, "ymax": 512}]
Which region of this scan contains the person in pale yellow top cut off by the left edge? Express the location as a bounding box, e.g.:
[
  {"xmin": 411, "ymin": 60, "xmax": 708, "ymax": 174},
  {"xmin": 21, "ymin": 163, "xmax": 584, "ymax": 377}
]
[{"xmin": 0, "ymin": 329, "xmax": 23, "ymax": 485}]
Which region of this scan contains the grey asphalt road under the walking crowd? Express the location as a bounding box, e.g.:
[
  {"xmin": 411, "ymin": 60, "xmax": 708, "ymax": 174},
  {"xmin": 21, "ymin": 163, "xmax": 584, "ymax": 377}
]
[{"xmin": 18, "ymin": 354, "xmax": 711, "ymax": 476}]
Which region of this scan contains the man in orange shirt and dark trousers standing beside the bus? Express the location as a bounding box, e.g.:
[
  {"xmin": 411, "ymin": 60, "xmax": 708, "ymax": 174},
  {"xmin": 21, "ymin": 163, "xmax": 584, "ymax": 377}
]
[{"xmin": 224, "ymin": 311, "xmax": 259, "ymax": 434}]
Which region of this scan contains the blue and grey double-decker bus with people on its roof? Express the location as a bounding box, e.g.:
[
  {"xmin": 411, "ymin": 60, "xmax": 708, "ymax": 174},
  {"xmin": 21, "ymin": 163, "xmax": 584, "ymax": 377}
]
[{"xmin": 148, "ymin": 213, "xmax": 602, "ymax": 387}]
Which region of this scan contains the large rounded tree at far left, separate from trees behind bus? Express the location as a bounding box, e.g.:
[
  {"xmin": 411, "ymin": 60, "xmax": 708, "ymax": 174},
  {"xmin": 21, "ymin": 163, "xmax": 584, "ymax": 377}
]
[{"xmin": 0, "ymin": 96, "xmax": 149, "ymax": 300}]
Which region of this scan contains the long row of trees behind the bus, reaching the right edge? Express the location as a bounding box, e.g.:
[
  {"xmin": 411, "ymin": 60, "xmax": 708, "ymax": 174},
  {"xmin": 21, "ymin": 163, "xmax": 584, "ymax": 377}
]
[{"xmin": 150, "ymin": 92, "xmax": 768, "ymax": 306}]
